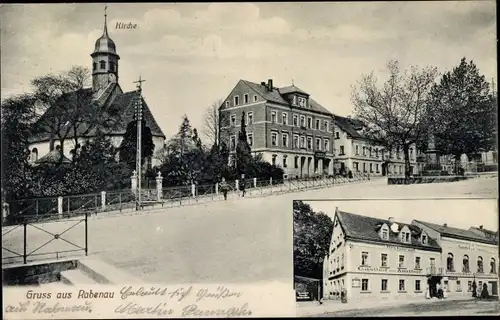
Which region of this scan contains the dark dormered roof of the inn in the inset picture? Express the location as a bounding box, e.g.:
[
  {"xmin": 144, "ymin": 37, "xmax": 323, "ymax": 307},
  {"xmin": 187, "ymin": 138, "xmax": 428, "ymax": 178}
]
[{"xmin": 337, "ymin": 210, "xmax": 441, "ymax": 251}]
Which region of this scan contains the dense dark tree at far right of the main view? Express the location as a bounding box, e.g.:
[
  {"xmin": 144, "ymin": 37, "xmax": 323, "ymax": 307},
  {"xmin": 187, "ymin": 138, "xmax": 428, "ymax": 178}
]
[{"xmin": 431, "ymin": 58, "xmax": 497, "ymax": 170}]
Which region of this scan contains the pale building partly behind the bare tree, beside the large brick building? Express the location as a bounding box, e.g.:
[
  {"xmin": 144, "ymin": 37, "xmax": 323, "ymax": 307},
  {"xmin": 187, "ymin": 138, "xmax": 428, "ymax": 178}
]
[{"xmin": 334, "ymin": 115, "xmax": 424, "ymax": 176}]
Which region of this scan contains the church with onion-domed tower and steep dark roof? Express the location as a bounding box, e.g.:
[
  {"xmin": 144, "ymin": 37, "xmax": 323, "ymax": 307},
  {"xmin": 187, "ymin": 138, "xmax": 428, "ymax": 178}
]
[{"xmin": 29, "ymin": 10, "xmax": 165, "ymax": 168}]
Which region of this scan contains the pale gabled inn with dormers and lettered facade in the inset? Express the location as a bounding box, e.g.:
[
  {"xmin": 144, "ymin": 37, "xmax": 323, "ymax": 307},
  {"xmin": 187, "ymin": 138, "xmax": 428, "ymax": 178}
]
[{"xmin": 323, "ymin": 209, "xmax": 441, "ymax": 302}]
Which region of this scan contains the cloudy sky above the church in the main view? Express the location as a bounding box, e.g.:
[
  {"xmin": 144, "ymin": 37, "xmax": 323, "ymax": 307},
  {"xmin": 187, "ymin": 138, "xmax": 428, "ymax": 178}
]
[{"xmin": 0, "ymin": 1, "xmax": 497, "ymax": 141}]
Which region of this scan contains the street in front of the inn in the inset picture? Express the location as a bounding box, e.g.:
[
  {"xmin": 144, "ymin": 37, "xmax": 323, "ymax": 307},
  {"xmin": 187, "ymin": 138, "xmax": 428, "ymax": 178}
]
[{"xmin": 315, "ymin": 300, "xmax": 500, "ymax": 317}]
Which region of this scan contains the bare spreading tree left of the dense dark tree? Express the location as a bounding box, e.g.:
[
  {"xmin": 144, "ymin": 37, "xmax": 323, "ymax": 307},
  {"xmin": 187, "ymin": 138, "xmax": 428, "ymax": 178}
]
[{"xmin": 352, "ymin": 61, "xmax": 437, "ymax": 178}]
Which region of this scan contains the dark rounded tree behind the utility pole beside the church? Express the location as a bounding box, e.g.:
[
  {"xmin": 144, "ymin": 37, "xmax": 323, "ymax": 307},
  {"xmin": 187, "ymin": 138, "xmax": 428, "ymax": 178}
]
[{"xmin": 119, "ymin": 119, "xmax": 155, "ymax": 170}]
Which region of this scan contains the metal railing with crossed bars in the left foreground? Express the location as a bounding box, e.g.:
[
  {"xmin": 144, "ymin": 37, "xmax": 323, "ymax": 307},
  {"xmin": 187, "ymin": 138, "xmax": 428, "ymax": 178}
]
[{"xmin": 2, "ymin": 214, "xmax": 88, "ymax": 265}]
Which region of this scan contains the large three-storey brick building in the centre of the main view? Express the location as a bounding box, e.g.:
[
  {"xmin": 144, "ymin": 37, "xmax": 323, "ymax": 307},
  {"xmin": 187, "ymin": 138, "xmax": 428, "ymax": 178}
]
[{"xmin": 219, "ymin": 79, "xmax": 334, "ymax": 177}]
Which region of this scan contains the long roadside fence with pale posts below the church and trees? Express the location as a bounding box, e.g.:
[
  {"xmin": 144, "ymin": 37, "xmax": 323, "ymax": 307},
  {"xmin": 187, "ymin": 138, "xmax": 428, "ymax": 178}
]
[{"xmin": 4, "ymin": 173, "xmax": 369, "ymax": 225}]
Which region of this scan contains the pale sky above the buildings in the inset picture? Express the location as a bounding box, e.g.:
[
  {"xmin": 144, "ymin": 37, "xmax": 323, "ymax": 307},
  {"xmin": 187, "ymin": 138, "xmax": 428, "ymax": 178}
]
[{"xmin": 304, "ymin": 199, "xmax": 498, "ymax": 231}]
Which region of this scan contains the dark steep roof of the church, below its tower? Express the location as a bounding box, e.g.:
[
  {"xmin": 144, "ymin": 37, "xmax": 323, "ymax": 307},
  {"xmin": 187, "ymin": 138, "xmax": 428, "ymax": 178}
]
[{"xmin": 30, "ymin": 83, "xmax": 165, "ymax": 143}]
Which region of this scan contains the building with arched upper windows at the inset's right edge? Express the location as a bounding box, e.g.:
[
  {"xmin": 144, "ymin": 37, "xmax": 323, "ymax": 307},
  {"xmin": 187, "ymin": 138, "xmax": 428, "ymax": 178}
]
[{"xmin": 412, "ymin": 220, "xmax": 499, "ymax": 296}]
